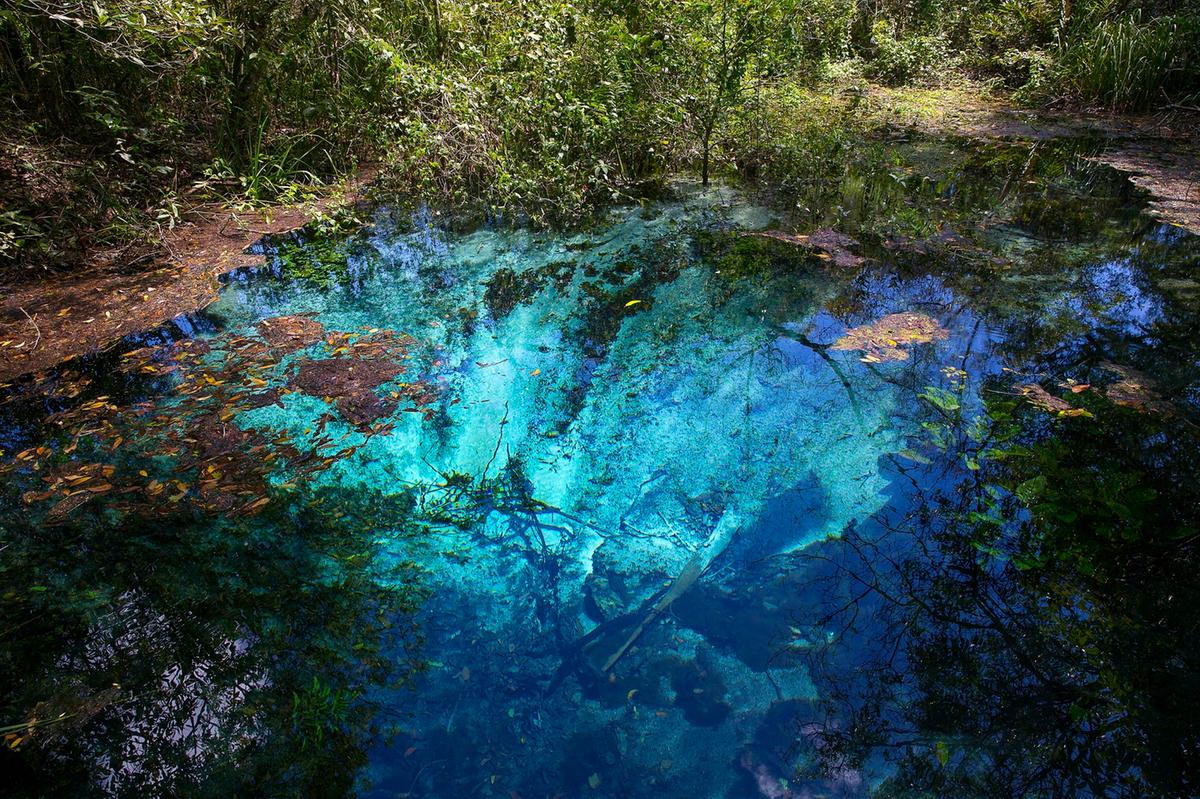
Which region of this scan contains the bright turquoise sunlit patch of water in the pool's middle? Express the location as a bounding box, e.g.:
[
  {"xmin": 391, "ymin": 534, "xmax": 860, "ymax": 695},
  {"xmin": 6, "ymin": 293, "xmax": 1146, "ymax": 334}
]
[{"xmin": 210, "ymin": 191, "xmax": 902, "ymax": 551}]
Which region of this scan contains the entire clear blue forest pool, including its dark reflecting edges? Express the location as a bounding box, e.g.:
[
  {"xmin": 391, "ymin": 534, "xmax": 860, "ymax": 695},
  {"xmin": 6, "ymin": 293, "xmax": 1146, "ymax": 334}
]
[{"xmin": 0, "ymin": 144, "xmax": 1200, "ymax": 799}]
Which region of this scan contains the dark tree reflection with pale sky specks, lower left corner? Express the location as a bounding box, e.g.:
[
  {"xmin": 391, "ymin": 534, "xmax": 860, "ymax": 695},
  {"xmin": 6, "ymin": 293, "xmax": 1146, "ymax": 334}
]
[{"xmin": 0, "ymin": 488, "xmax": 421, "ymax": 797}]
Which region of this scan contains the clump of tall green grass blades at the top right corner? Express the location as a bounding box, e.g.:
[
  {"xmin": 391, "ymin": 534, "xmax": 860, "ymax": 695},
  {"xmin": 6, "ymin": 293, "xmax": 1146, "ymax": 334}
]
[{"xmin": 1055, "ymin": 14, "xmax": 1200, "ymax": 110}]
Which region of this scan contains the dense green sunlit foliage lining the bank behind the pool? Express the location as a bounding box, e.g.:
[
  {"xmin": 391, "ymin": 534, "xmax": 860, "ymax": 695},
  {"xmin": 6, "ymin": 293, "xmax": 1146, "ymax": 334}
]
[{"xmin": 0, "ymin": 0, "xmax": 1200, "ymax": 266}]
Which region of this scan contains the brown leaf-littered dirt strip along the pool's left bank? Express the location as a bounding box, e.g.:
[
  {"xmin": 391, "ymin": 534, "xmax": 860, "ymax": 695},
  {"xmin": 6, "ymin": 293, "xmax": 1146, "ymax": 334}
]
[{"xmin": 0, "ymin": 175, "xmax": 370, "ymax": 388}]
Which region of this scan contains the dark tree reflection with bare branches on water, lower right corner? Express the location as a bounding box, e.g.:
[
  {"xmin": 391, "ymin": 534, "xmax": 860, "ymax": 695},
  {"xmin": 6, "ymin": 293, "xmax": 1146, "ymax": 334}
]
[{"xmin": 800, "ymin": 383, "xmax": 1200, "ymax": 797}]
